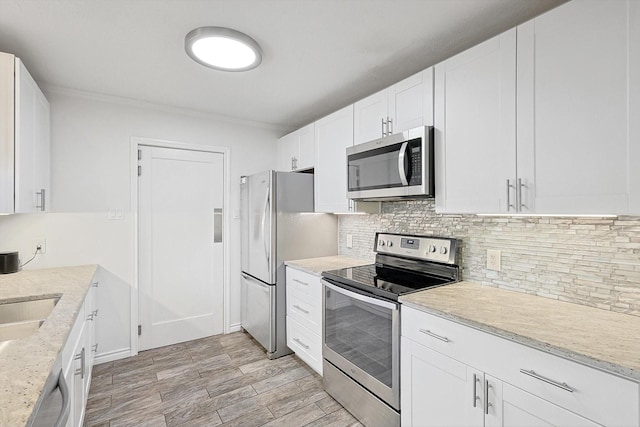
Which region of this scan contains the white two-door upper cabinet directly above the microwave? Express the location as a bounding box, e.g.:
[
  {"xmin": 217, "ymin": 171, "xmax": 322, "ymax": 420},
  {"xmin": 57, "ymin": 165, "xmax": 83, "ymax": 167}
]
[{"xmin": 354, "ymin": 68, "xmax": 433, "ymax": 144}]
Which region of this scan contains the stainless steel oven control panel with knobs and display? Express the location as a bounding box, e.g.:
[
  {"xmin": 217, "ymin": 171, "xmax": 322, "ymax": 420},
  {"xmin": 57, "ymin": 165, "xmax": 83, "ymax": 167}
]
[{"xmin": 374, "ymin": 233, "xmax": 457, "ymax": 264}]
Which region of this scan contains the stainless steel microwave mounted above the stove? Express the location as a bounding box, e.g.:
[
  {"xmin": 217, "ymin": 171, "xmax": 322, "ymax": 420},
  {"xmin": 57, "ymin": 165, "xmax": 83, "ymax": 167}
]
[{"xmin": 347, "ymin": 126, "xmax": 434, "ymax": 200}]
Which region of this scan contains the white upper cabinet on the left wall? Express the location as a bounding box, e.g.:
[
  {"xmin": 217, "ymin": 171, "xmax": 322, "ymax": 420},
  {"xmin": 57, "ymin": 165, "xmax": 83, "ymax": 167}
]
[{"xmin": 0, "ymin": 53, "xmax": 50, "ymax": 213}]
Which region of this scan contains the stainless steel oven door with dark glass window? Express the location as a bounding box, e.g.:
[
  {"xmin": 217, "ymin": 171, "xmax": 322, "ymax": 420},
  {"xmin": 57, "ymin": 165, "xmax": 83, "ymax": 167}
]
[{"xmin": 322, "ymin": 280, "xmax": 400, "ymax": 410}]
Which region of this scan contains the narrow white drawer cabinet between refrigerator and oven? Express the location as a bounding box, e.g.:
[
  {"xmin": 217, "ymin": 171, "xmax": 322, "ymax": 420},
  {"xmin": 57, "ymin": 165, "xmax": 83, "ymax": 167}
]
[{"xmin": 286, "ymin": 266, "xmax": 322, "ymax": 375}]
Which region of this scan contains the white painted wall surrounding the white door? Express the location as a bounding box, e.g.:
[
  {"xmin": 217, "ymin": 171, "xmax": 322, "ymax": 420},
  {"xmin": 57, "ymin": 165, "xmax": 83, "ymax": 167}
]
[{"xmin": 0, "ymin": 91, "xmax": 282, "ymax": 359}]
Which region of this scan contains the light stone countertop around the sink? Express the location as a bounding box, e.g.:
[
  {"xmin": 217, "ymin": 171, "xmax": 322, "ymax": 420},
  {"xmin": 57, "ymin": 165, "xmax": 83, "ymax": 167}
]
[{"xmin": 0, "ymin": 265, "xmax": 98, "ymax": 427}]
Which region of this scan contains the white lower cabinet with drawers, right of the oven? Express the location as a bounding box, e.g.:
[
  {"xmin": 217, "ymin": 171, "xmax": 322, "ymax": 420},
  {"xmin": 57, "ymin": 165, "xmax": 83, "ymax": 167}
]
[{"xmin": 400, "ymin": 306, "xmax": 640, "ymax": 427}]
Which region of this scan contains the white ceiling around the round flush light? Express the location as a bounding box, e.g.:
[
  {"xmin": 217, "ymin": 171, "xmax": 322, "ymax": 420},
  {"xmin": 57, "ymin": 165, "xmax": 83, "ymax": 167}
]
[{"xmin": 0, "ymin": 0, "xmax": 564, "ymax": 129}]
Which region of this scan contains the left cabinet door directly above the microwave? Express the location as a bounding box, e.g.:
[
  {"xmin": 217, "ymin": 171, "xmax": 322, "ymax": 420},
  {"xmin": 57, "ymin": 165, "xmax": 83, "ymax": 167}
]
[{"xmin": 353, "ymin": 89, "xmax": 389, "ymax": 144}]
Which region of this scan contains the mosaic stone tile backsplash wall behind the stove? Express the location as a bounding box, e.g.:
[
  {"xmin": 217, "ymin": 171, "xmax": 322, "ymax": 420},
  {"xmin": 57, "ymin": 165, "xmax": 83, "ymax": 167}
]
[{"xmin": 339, "ymin": 200, "xmax": 640, "ymax": 316}]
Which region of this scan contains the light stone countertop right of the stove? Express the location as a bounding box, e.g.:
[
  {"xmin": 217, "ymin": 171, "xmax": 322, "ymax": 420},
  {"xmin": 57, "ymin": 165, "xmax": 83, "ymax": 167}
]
[{"xmin": 400, "ymin": 281, "xmax": 640, "ymax": 381}]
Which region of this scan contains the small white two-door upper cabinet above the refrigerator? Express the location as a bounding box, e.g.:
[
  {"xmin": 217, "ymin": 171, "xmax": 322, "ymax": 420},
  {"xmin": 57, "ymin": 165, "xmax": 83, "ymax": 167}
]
[{"xmin": 278, "ymin": 123, "xmax": 316, "ymax": 172}]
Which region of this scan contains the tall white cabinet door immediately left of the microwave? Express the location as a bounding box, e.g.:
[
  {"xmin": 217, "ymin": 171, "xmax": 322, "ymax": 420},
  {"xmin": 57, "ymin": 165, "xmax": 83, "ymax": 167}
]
[{"xmin": 314, "ymin": 105, "xmax": 353, "ymax": 212}]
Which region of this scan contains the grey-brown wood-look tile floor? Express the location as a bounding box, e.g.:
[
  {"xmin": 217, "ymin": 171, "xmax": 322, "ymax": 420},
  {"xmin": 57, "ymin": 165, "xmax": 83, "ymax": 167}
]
[{"xmin": 84, "ymin": 332, "xmax": 362, "ymax": 427}]
